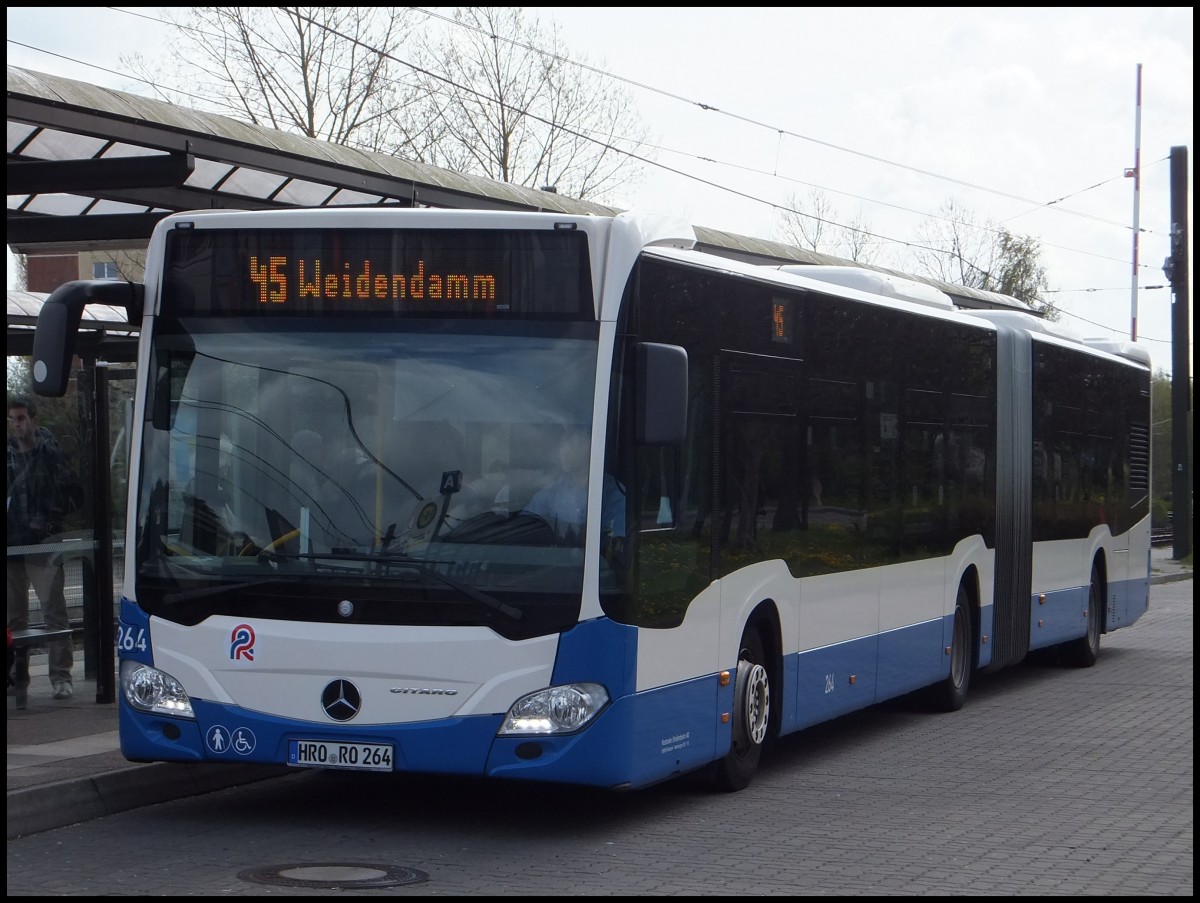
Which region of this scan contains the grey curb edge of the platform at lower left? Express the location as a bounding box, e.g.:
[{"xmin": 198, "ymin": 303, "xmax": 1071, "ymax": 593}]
[{"xmin": 8, "ymin": 763, "xmax": 294, "ymax": 841}]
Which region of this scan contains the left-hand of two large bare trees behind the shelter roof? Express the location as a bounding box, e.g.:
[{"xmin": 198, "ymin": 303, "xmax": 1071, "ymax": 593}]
[{"xmin": 122, "ymin": 6, "xmax": 422, "ymax": 150}]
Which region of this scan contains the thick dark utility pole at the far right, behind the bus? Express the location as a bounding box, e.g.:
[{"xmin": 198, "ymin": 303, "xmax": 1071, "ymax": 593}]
[{"xmin": 1163, "ymin": 146, "xmax": 1192, "ymax": 558}]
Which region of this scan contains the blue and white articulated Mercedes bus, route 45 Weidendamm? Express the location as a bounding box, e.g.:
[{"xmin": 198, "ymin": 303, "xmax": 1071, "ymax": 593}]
[{"xmin": 34, "ymin": 209, "xmax": 1151, "ymax": 790}]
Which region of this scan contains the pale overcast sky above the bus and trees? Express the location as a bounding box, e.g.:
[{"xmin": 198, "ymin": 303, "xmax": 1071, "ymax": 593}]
[{"xmin": 7, "ymin": 7, "xmax": 1194, "ymax": 371}]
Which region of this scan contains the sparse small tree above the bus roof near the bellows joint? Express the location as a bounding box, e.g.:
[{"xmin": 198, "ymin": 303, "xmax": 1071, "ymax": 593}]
[{"xmin": 910, "ymin": 199, "xmax": 1061, "ymax": 319}]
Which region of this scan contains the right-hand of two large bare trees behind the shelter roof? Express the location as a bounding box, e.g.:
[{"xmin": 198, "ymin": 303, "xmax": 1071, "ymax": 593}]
[{"xmin": 394, "ymin": 6, "xmax": 646, "ymax": 198}]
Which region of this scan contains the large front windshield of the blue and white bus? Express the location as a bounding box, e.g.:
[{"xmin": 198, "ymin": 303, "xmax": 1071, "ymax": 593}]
[{"xmin": 137, "ymin": 318, "xmax": 598, "ymax": 629}]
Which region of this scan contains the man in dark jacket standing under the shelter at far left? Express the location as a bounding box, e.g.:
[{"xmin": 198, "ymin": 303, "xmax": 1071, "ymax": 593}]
[{"xmin": 8, "ymin": 396, "xmax": 83, "ymax": 699}]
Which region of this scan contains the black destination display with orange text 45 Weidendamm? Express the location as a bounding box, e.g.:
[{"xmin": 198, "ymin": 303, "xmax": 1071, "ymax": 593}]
[{"xmin": 162, "ymin": 229, "xmax": 594, "ymax": 318}]
